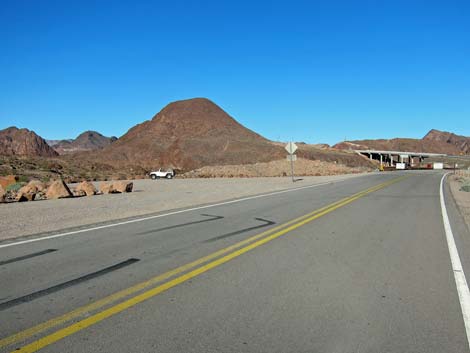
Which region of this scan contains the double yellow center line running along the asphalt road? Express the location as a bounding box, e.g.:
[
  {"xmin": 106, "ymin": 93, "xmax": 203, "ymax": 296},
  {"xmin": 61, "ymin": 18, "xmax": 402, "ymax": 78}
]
[{"xmin": 0, "ymin": 177, "xmax": 406, "ymax": 352}]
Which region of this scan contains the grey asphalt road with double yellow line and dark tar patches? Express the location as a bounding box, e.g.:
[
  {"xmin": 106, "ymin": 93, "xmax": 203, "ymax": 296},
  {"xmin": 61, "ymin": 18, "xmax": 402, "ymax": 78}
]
[{"xmin": 0, "ymin": 172, "xmax": 470, "ymax": 353}]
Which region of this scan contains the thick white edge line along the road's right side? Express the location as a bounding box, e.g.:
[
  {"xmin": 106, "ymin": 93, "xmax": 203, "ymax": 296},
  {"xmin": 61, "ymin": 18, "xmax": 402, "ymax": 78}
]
[{"xmin": 440, "ymin": 173, "xmax": 470, "ymax": 348}]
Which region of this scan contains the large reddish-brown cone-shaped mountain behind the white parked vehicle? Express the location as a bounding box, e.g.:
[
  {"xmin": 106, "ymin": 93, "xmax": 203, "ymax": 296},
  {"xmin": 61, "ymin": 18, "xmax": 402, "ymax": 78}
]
[{"xmin": 82, "ymin": 98, "xmax": 286, "ymax": 170}]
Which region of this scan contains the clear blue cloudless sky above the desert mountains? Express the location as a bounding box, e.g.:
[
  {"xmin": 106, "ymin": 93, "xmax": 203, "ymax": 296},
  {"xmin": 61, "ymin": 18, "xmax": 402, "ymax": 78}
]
[{"xmin": 0, "ymin": 0, "xmax": 470, "ymax": 143}]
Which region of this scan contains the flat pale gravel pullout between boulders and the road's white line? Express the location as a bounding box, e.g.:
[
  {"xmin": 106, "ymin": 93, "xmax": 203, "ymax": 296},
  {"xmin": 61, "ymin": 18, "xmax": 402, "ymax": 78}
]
[{"xmin": 0, "ymin": 174, "xmax": 364, "ymax": 241}]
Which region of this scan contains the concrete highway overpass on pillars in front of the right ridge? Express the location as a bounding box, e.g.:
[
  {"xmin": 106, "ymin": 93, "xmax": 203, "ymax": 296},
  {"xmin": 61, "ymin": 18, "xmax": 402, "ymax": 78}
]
[{"xmin": 355, "ymin": 150, "xmax": 447, "ymax": 167}]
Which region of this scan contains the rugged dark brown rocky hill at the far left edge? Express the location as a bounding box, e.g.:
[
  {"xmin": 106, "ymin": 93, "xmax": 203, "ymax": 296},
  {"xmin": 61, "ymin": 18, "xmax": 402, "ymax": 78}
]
[{"xmin": 0, "ymin": 127, "xmax": 58, "ymax": 157}]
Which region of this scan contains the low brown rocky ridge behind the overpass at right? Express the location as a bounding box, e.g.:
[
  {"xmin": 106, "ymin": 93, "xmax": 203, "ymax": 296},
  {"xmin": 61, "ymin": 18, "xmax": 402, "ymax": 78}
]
[{"xmin": 333, "ymin": 130, "xmax": 470, "ymax": 155}]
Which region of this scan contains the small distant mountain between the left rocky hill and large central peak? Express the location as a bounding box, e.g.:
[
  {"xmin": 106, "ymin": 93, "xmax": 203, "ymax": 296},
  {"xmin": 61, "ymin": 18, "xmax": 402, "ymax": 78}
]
[{"xmin": 49, "ymin": 131, "xmax": 117, "ymax": 155}]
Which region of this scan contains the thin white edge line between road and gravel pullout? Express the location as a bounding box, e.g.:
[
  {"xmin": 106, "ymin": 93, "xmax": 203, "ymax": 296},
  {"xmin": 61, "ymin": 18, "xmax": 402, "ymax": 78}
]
[{"xmin": 0, "ymin": 178, "xmax": 364, "ymax": 249}]
